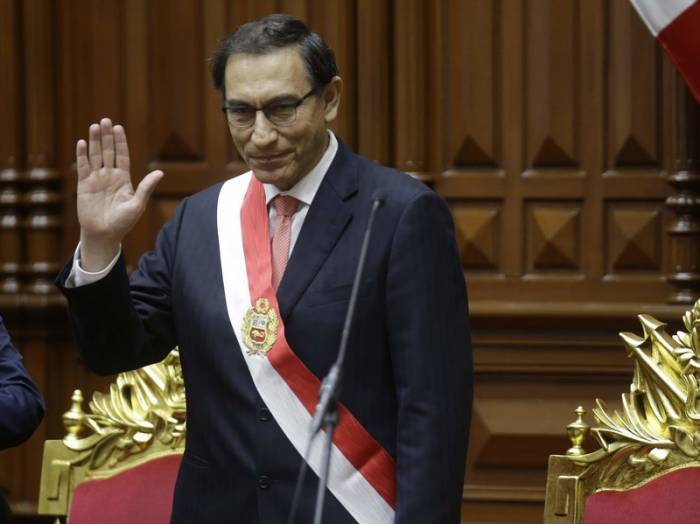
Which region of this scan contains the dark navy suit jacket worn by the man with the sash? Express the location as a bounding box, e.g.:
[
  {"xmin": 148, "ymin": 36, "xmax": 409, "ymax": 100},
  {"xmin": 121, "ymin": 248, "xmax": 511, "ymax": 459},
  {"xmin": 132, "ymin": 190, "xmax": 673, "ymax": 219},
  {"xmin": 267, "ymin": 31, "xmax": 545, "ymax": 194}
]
[{"xmin": 57, "ymin": 144, "xmax": 472, "ymax": 524}]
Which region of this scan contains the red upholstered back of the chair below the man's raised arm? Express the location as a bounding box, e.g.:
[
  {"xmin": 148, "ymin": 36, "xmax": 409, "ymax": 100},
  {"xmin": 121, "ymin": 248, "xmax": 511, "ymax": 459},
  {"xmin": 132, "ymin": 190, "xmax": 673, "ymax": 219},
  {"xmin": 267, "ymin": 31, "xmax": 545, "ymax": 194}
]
[{"xmin": 68, "ymin": 453, "xmax": 182, "ymax": 524}]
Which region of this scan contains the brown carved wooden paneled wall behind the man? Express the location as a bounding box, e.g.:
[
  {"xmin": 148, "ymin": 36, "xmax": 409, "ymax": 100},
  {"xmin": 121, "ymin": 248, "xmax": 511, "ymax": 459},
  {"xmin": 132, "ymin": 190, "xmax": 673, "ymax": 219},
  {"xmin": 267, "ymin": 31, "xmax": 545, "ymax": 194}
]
[{"xmin": 0, "ymin": 0, "xmax": 700, "ymax": 523}]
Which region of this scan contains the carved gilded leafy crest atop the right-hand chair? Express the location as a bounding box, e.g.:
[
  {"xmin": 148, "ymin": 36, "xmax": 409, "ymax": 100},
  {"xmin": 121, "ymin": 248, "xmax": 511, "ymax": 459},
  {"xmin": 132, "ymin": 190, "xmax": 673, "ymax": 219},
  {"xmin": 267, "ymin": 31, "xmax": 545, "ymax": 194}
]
[{"xmin": 567, "ymin": 300, "xmax": 700, "ymax": 490}]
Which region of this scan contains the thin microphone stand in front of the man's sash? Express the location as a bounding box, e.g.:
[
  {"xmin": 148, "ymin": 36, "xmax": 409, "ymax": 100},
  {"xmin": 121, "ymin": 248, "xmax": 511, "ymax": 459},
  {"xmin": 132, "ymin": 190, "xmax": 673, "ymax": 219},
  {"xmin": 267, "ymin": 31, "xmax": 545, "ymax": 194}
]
[{"xmin": 287, "ymin": 190, "xmax": 384, "ymax": 524}]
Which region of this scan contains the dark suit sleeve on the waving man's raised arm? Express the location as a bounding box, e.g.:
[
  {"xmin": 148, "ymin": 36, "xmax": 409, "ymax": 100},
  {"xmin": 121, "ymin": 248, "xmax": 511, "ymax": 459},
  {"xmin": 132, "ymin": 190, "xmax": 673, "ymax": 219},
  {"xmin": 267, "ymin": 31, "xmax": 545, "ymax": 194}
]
[{"xmin": 56, "ymin": 200, "xmax": 186, "ymax": 375}]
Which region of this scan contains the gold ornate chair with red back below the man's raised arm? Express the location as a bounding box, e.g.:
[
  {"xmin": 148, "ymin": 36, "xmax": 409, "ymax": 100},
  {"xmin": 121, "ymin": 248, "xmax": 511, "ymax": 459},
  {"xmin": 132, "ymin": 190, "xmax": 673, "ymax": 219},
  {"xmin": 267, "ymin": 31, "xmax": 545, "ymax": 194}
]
[{"xmin": 39, "ymin": 349, "xmax": 186, "ymax": 524}]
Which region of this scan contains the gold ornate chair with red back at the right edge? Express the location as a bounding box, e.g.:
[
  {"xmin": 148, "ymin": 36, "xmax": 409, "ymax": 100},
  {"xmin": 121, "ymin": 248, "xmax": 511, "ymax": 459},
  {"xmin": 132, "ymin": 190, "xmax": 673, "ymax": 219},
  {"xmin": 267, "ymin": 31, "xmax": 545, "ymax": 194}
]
[{"xmin": 544, "ymin": 301, "xmax": 700, "ymax": 524}]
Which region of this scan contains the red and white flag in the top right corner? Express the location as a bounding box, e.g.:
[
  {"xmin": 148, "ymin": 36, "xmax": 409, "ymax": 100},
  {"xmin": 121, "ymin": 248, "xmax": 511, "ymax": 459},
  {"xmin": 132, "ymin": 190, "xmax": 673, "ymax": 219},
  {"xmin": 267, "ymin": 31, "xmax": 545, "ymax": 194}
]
[{"xmin": 631, "ymin": 0, "xmax": 700, "ymax": 102}]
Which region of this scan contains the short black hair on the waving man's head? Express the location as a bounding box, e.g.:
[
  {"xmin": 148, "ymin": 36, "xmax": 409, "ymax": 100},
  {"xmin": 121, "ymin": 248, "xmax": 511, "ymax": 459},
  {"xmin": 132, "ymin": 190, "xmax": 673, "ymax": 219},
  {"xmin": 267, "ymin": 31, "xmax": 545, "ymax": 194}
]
[{"xmin": 211, "ymin": 14, "xmax": 338, "ymax": 94}]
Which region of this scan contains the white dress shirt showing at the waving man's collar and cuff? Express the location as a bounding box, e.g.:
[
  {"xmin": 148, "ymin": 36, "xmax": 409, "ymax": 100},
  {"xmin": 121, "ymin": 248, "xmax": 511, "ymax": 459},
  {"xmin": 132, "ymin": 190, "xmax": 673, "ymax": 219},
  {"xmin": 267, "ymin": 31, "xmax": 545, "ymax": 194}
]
[{"xmin": 66, "ymin": 131, "xmax": 338, "ymax": 287}]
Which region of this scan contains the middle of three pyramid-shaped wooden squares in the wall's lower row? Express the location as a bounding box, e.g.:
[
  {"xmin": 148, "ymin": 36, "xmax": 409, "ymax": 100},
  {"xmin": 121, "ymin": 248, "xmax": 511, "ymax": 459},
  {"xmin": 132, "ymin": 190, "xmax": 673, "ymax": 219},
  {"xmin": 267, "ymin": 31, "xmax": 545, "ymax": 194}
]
[{"xmin": 524, "ymin": 201, "xmax": 581, "ymax": 273}]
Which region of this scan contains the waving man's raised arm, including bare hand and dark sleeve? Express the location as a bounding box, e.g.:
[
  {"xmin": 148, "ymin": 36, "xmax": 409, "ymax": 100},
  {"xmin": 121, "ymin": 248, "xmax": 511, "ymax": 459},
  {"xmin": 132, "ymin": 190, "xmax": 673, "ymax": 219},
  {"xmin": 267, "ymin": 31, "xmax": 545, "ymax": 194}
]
[{"xmin": 56, "ymin": 118, "xmax": 170, "ymax": 374}]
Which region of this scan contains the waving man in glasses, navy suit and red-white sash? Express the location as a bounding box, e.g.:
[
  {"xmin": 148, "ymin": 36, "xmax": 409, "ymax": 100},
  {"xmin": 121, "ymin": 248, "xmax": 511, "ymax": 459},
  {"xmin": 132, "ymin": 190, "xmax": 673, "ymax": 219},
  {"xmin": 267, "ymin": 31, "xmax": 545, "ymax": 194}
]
[{"xmin": 54, "ymin": 15, "xmax": 472, "ymax": 524}]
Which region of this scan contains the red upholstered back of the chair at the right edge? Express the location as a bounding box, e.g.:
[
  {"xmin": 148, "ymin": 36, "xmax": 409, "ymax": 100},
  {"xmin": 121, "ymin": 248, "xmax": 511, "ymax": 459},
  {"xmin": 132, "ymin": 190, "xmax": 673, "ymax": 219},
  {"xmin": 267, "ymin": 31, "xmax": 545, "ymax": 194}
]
[{"xmin": 583, "ymin": 467, "xmax": 700, "ymax": 524}]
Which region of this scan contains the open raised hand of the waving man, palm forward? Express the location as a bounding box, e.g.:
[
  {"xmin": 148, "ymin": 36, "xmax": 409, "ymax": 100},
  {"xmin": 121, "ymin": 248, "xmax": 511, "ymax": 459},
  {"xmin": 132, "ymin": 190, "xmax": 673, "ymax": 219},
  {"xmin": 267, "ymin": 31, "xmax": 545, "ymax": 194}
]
[{"xmin": 75, "ymin": 118, "xmax": 163, "ymax": 272}]
